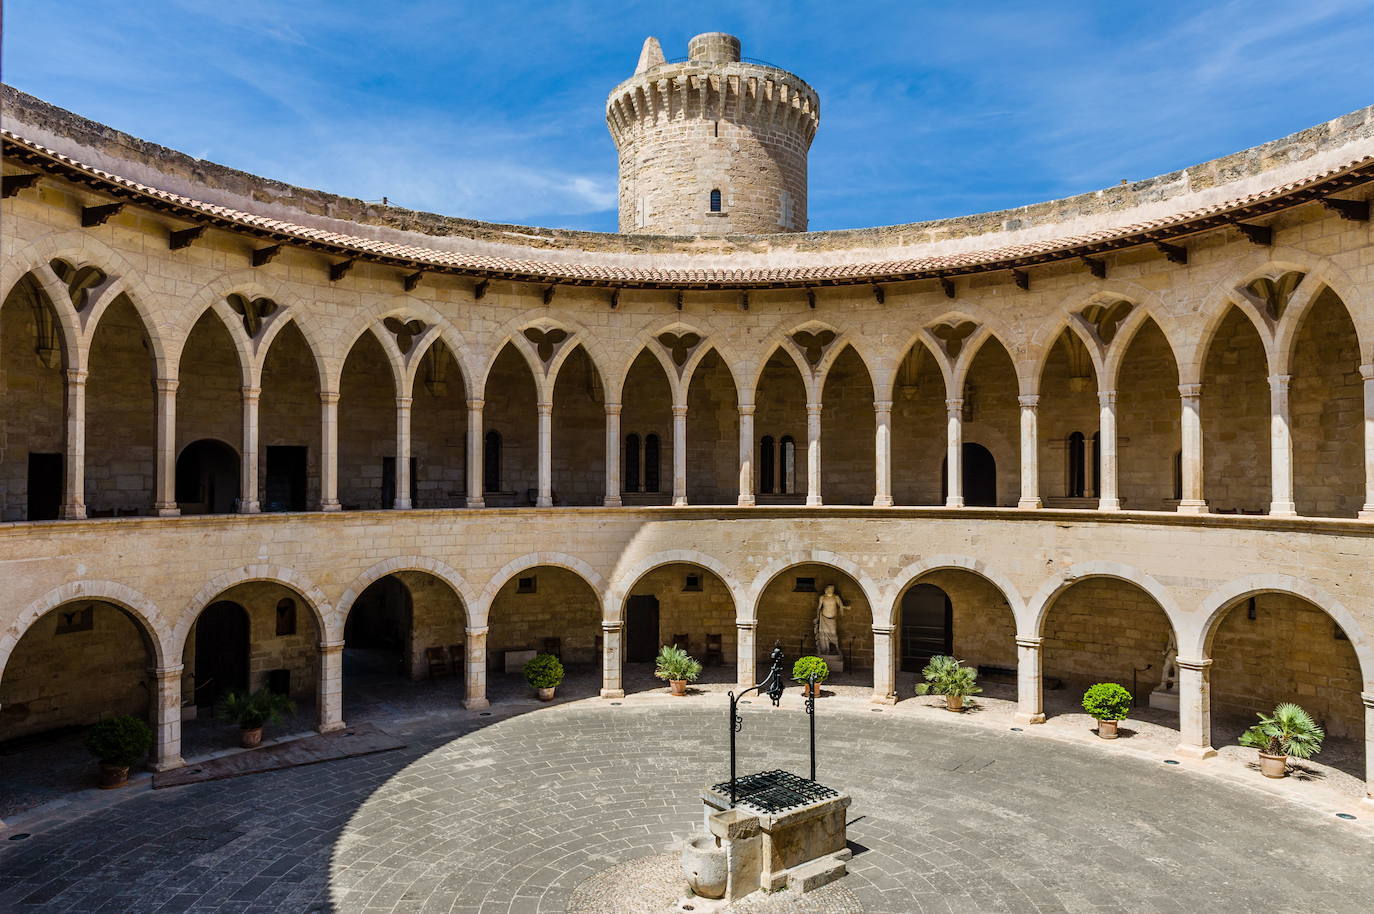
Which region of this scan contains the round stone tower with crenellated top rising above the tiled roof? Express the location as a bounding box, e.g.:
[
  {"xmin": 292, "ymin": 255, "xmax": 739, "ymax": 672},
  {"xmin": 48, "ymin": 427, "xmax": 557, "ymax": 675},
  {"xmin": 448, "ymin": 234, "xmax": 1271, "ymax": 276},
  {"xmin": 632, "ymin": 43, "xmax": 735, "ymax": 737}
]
[{"xmin": 606, "ymin": 32, "xmax": 820, "ymax": 235}]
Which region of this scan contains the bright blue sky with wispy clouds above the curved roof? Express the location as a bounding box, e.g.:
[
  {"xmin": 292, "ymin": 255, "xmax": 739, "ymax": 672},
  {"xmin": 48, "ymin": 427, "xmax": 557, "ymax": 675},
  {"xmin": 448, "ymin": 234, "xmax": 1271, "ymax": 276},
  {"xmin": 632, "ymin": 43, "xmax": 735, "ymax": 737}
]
[{"xmin": 3, "ymin": 0, "xmax": 1374, "ymax": 231}]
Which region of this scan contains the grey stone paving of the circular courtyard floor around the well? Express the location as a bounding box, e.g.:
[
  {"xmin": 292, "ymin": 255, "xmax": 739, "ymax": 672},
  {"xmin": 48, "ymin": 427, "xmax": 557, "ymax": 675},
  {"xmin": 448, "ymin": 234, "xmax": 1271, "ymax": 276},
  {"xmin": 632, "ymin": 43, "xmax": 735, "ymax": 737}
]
[{"xmin": 0, "ymin": 698, "xmax": 1374, "ymax": 914}]
